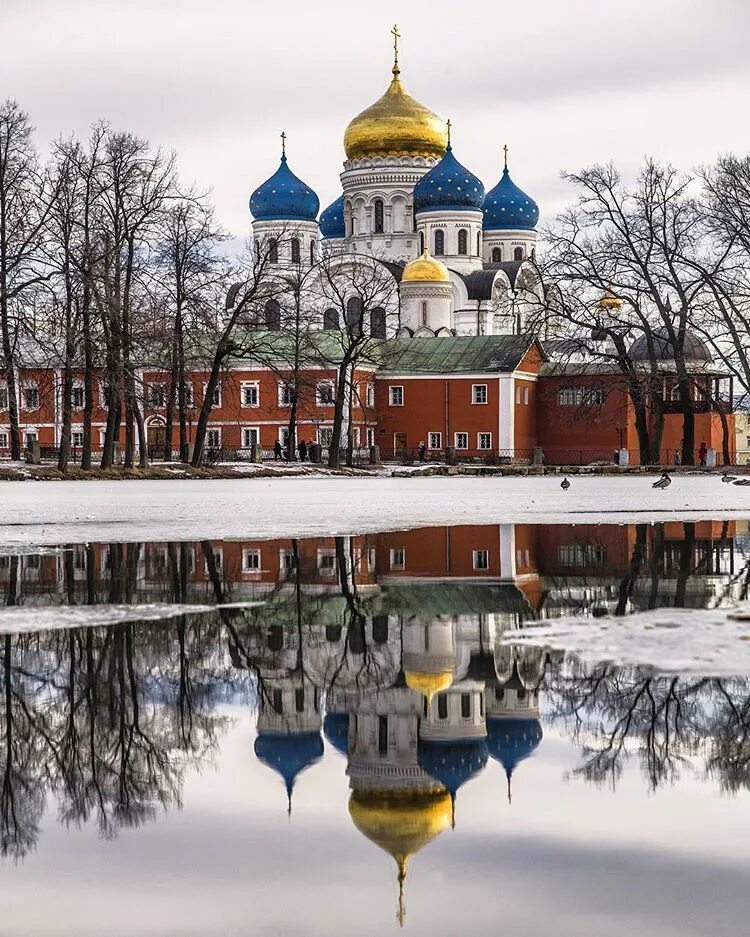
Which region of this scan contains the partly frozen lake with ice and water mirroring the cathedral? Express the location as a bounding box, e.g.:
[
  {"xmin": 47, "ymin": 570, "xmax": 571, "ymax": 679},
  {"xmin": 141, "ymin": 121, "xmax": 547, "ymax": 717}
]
[{"xmin": 0, "ymin": 520, "xmax": 750, "ymax": 937}]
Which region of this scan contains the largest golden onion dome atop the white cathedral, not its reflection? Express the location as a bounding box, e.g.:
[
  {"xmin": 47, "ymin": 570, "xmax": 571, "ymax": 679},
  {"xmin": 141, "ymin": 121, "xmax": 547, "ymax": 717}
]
[{"xmin": 344, "ymin": 66, "xmax": 448, "ymax": 159}]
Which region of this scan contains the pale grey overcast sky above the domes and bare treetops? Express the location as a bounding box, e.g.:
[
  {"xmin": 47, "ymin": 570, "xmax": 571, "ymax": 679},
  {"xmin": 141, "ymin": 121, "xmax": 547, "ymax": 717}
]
[{"xmin": 0, "ymin": 0, "xmax": 750, "ymax": 236}]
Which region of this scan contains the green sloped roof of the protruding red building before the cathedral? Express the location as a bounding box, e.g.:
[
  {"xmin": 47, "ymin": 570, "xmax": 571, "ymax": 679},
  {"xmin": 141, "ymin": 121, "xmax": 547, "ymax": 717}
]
[{"xmin": 381, "ymin": 335, "xmax": 536, "ymax": 374}]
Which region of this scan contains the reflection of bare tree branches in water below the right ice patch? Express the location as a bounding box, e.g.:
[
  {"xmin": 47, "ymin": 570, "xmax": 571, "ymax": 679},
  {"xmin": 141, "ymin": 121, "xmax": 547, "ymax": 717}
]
[{"xmin": 547, "ymin": 662, "xmax": 750, "ymax": 791}]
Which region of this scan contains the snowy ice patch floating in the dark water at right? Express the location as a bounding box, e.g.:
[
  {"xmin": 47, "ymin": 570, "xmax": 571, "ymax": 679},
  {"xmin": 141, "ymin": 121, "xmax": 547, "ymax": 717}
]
[{"xmin": 505, "ymin": 608, "xmax": 750, "ymax": 676}]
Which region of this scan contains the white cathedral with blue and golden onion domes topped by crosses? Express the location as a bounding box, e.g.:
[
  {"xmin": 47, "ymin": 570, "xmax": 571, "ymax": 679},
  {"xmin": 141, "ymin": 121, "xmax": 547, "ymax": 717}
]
[{"xmin": 250, "ymin": 27, "xmax": 545, "ymax": 338}]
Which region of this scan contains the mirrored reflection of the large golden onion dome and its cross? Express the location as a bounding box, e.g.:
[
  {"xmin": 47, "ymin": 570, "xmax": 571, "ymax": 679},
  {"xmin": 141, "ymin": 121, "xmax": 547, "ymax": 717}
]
[{"xmin": 349, "ymin": 786, "xmax": 452, "ymax": 924}]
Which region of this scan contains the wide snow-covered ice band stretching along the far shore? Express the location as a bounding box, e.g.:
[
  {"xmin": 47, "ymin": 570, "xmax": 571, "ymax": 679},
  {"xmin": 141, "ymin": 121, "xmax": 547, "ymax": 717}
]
[{"xmin": 0, "ymin": 475, "xmax": 750, "ymax": 552}]
